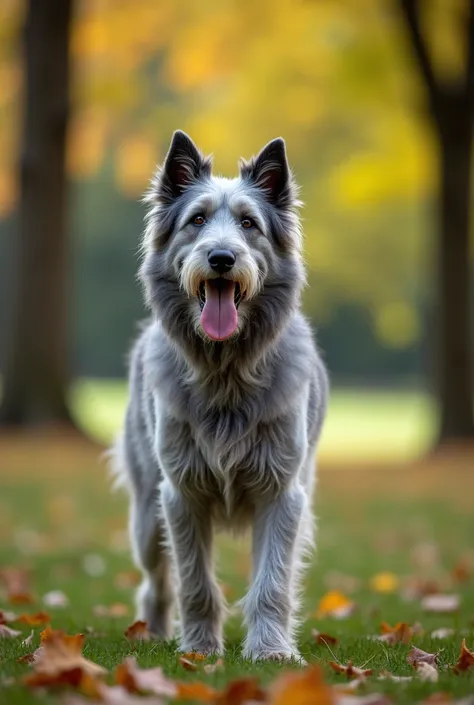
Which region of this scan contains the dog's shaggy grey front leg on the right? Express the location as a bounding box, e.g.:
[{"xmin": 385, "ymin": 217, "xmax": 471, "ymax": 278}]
[{"xmin": 243, "ymin": 484, "xmax": 309, "ymax": 660}]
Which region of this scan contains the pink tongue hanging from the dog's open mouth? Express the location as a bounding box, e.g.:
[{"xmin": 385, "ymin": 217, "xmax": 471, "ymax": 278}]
[{"xmin": 201, "ymin": 279, "xmax": 238, "ymax": 340}]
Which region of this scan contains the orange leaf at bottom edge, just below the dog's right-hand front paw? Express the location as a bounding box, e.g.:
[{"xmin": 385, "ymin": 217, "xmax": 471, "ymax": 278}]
[{"xmin": 270, "ymin": 666, "xmax": 338, "ymax": 705}]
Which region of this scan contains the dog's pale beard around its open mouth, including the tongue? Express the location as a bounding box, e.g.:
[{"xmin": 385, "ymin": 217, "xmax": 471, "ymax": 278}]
[{"xmin": 180, "ymin": 257, "xmax": 261, "ymax": 341}]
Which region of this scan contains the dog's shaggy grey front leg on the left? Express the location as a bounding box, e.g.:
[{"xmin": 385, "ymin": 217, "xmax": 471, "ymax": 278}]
[{"xmin": 161, "ymin": 479, "xmax": 223, "ymax": 653}]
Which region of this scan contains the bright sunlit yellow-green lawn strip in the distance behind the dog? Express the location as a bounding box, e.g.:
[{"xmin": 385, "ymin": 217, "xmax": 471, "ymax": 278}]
[{"xmin": 72, "ymin": 380, "xmax": 436, "ymax": 461}]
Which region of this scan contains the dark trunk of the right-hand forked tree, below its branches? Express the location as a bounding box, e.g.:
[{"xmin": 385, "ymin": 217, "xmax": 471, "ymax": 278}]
[{"xmin": 437, "ymin": 110, "xmax": 474, "ymax": 444}]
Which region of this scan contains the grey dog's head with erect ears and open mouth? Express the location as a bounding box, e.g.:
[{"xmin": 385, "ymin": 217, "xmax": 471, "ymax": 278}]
[{"xmin": 141, "ymin": 132, "xmax": 304, "ymax": 358}]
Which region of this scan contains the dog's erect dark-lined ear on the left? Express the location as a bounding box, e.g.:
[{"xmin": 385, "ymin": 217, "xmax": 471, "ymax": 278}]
[{"xmin": 158, "ymin": 130, "xmax": 211, "ymax": 201}]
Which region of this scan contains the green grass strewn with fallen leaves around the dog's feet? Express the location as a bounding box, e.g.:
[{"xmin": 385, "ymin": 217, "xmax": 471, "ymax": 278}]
[{"xmin": 0, "ymin": 432, "xmax": 474, "ymax": 705}]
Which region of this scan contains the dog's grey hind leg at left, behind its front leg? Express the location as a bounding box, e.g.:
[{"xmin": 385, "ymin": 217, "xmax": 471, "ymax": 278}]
[{"xmin": 130, "ymin": 493, "xmax": 173, "ymax": 639}]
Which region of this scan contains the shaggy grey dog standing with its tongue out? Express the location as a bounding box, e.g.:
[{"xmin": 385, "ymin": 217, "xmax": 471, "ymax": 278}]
[{"xmin": 116, "ymin": 132, "xmax": 328, "ymax": 660}]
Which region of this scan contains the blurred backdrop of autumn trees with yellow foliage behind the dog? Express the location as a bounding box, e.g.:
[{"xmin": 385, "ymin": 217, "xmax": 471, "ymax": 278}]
[{"xmin": 0, "ymin": 0, "xmax": 474, "ymax": 452}]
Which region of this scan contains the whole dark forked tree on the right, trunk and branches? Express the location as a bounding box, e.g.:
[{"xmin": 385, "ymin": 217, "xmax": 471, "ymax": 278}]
[{"xmin": 399, "ymin": 0, "xmax": 474, "ymax": 443}]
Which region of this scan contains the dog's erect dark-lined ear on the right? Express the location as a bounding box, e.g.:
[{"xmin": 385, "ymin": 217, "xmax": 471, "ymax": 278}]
[{"xmin": 240, "ymin": 137, "xmax": 292, "ymax": 207}]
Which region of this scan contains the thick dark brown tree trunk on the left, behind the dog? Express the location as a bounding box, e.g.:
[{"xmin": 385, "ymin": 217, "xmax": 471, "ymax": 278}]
[{"xmin": 0, "ymin": 0, "xmax": 72, "ymax": 426}]
